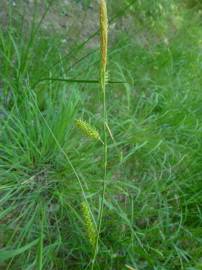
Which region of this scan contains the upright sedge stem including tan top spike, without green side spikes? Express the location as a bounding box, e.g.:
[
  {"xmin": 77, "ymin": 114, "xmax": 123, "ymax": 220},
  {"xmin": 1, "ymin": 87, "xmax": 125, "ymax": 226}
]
[{"xmin": 91, "ymin": 0, "xmax": 108, "ymax": 270}]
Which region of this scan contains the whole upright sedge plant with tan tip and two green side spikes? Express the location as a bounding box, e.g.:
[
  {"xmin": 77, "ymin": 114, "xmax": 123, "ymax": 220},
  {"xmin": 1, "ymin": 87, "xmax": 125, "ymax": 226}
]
[{"xmin": 76, "ymin": 0, "xmax": 108, "ymax": 269}]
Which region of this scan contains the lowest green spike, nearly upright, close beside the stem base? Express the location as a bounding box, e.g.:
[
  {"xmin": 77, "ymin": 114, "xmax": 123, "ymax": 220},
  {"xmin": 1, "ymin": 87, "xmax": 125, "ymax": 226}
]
[{"xmin": 81, "ymin": 201, "xmax": 97, "ymax": 249}]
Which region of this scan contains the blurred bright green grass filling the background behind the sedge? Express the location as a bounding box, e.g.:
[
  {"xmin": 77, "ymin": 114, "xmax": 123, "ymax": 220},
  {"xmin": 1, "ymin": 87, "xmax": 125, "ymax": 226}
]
[{"xmin": 0, "ymin": 1, "xmax": 202, "ymax": 270}]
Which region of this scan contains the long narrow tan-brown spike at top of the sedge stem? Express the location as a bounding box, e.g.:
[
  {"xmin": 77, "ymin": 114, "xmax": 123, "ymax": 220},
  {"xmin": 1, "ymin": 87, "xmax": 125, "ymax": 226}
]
[{"xmin": 100, "ymin": 0, "xmax": 108, "ymax": 76}]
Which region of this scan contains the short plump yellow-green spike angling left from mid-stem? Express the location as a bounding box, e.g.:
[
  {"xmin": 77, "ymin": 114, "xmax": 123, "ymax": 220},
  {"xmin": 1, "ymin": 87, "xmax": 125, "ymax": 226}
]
[{"xmin": 76, "ymin": 119, "xmax": 101, "ymax": 140}]
